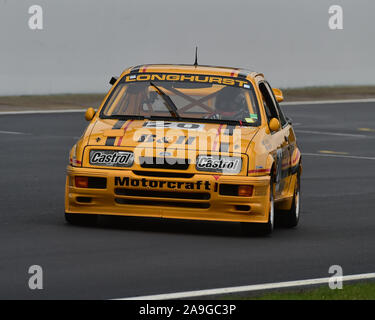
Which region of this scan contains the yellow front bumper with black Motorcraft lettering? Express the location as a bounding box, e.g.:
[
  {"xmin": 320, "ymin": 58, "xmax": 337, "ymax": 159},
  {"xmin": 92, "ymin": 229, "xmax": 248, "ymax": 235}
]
[{"xmin": 65, "ymin": 166, "xmax": 270, "ymax": 223}]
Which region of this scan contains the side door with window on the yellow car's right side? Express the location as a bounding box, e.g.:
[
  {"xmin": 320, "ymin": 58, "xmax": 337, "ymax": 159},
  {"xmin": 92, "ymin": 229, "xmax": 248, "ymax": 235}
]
[{"xmin": 259, "ymin": 81, "xmax": 291, "ymax": 199}]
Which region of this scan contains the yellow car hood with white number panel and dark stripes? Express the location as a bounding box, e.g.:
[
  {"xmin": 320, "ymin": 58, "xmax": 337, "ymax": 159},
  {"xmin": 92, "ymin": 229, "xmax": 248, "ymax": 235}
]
[{"xmin": 88, "ymin": 119, "xmax": 258, "ymax": 153}]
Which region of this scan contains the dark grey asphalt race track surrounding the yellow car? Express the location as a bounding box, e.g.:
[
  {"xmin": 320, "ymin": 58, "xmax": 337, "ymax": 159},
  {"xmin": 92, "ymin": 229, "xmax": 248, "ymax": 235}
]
[{"xmin": 0, "ymin": 103, "xmax": 375, "ymax": 299}]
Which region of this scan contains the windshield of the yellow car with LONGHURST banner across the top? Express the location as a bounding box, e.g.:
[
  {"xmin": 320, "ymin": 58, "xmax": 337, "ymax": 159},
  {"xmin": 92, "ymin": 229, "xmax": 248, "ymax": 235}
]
[{"xmin": 100, "ymin": 73, "xmax": 260, "ymax": 126}]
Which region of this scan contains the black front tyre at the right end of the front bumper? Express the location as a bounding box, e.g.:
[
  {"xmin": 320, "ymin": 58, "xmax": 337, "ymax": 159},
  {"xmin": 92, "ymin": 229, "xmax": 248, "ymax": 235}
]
[{"xmin": 241, "ymin": 177, "xmax": 275, "ymax": 236}]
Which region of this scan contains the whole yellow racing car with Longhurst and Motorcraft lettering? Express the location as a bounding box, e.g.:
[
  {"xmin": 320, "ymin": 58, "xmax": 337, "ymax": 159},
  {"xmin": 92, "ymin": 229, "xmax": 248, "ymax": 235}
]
[{"xmin": 65, "ymin": 65, "xmax": 302, "ymax": 234}]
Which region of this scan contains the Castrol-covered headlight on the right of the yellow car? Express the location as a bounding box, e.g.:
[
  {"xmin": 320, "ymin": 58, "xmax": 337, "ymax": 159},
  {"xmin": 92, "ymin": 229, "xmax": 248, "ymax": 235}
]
[{"xmin": 195, "ymin": 156, "xmax": 242, "ymax": 173}]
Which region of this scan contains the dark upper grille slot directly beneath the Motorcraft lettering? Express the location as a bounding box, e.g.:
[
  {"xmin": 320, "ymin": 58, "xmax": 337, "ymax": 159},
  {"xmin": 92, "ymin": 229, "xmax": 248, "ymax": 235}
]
[{"xmin": 115, "ymin": 188, "xmax": 211, "ymax": 200}]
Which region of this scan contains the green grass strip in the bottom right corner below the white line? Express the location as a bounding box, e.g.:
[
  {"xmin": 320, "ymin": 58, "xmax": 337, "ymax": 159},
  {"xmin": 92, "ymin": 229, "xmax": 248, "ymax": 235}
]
[{"xmin": 220, "ymin": 282, "xmax": 375, "ymax": 300}]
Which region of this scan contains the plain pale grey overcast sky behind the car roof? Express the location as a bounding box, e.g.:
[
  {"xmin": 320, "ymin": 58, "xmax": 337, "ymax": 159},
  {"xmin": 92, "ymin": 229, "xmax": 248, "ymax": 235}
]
[{"xmin": 0, "ymin": 0, "xmax": 375, "ymax": 95}]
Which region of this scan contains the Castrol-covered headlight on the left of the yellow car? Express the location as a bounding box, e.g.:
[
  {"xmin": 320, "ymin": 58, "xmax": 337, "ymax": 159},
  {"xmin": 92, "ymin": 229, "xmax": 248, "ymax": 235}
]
[{"xmin": 90, "ymin": 150, "xmax": 134, "ymax": 167}]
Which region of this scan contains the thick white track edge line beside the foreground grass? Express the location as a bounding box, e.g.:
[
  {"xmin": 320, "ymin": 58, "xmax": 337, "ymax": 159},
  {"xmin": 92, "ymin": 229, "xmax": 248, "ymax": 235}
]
[{"xmin": 119, "ymin": 273, "xmax": 375, "ymax": 300}]
